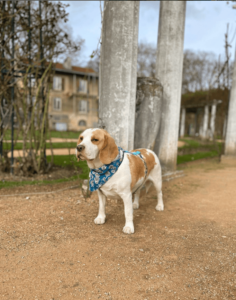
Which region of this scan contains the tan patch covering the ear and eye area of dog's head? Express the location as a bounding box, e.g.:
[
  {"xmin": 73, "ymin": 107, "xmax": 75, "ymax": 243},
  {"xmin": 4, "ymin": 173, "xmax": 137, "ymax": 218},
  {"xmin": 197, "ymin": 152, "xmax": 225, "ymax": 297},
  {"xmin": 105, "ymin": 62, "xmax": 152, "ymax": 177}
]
[{"xmin": 91, "ymin": 129, "xmax": 119, "ymax": 165}]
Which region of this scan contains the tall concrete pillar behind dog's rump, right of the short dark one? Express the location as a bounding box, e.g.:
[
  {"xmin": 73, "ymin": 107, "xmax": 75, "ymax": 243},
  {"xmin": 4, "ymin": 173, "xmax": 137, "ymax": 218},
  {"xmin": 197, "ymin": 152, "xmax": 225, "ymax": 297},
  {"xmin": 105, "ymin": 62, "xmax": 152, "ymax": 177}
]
[{"xmin": 154, "ymin": 1, "xmax": 186, "ymax": 171}]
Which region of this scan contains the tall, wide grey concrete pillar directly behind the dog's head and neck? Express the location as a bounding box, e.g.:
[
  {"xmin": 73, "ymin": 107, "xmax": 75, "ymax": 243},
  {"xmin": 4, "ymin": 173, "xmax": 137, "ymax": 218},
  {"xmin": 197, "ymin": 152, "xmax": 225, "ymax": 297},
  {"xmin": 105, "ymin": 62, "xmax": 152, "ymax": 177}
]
[{"xmin": 99, "ymin": 1, "xmax": 139, "ymax": 150}]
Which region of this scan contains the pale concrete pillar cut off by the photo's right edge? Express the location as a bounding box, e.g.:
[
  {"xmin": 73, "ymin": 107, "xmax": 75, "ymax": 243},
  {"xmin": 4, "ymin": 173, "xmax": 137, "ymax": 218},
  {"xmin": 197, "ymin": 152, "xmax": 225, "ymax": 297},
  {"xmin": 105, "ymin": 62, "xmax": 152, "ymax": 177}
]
[{"xmin": 225, "ymin": 49, "xmax": 236, "ymax": 156}]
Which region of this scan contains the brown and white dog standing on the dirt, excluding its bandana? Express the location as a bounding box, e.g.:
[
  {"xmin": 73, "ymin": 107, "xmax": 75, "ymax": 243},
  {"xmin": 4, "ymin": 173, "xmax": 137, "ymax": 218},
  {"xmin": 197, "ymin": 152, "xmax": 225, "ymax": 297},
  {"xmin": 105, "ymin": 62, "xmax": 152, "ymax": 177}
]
[{"xmin": 76, "ymin": 128, "xmax": 164, "ymax": 234}]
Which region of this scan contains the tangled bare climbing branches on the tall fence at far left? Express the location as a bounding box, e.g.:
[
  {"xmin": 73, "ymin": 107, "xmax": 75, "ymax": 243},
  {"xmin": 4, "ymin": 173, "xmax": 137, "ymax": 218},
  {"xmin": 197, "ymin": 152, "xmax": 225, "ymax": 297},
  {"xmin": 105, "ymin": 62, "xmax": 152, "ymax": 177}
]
[{"xmin": 0, "ymin": 1, "xmax": 83, "ymax": 175}]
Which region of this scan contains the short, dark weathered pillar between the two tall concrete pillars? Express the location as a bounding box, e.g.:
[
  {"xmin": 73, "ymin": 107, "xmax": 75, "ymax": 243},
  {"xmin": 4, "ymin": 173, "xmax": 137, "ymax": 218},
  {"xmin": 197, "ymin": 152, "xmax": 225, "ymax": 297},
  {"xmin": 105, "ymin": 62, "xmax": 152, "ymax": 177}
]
[{"xmin": 134, "ymin": 77, "xmax": 163, "ymax": 150}]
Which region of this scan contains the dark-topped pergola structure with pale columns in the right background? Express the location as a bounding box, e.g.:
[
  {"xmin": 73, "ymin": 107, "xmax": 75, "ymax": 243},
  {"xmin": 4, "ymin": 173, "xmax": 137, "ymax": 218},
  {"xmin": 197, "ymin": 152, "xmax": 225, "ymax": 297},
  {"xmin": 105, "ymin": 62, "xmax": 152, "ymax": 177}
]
[{"xmin": 179, "ymin": 89, "xmax": 229, "ymax": 139}]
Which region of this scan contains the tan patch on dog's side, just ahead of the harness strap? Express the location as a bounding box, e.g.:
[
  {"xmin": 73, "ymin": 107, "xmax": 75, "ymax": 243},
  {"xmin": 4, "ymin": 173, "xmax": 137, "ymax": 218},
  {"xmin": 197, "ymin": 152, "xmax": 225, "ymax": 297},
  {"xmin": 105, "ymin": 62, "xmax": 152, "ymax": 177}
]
[{"xmin": 128, "ymin": 155, "xmax": 145, "ymax": 190}]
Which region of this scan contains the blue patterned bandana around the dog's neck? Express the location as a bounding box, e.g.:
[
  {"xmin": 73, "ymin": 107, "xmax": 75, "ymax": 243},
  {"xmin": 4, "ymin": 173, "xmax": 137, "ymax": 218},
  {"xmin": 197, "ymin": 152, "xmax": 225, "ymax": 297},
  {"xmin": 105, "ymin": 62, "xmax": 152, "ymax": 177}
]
[{"xmin": 89, "ymin": 147, "xmax": 141, "ymax": 192}]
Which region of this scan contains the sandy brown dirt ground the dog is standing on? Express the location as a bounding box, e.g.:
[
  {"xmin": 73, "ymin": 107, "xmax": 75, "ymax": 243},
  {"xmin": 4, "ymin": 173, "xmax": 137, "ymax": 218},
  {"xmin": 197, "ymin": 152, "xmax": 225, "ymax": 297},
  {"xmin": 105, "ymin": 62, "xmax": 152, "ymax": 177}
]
[{"xmin": 0, "ymin": 162, "xmax": 236, "ymax": 300}]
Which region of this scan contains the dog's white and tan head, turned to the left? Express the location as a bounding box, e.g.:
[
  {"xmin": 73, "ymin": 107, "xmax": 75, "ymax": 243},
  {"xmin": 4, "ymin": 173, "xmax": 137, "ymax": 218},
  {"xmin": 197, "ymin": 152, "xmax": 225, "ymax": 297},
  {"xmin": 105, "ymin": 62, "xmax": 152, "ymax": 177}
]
[{"xmin": 76, "ymin": 128, "xmax": 118, "ymax": 164}]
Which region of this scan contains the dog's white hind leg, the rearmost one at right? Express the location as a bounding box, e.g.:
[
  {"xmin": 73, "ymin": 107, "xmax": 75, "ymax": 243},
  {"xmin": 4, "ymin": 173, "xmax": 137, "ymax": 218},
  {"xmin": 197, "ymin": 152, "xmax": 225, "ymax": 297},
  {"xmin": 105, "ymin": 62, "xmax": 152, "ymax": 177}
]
[{"xmin": 148, "ymin": 165, "xmax": 164, "ymax": 211}]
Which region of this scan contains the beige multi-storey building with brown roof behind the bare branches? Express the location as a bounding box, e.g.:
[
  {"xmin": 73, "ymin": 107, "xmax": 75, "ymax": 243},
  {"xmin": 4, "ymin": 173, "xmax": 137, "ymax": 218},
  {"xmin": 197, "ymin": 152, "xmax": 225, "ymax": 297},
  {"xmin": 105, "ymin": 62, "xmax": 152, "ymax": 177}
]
[{"xmin": 48, "ymin": 58, "xmax": 98, "ymax": 131}]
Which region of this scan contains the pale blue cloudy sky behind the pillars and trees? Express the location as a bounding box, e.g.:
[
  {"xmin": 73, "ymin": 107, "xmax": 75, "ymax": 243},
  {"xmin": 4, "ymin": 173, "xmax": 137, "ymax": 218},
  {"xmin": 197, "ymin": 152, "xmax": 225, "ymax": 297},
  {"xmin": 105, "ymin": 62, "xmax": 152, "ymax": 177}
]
[{"xmin": 61, "ymin": 1, "xmax": 236, "ymax": 66}]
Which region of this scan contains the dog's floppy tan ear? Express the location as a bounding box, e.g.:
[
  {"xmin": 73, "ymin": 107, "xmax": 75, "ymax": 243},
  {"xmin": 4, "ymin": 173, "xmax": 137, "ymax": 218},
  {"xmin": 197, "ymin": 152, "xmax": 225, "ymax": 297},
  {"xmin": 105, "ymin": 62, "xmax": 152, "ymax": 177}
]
[{"xmin": 99, "ymin": 132, "xmax": 119, "ymax": 165}]
